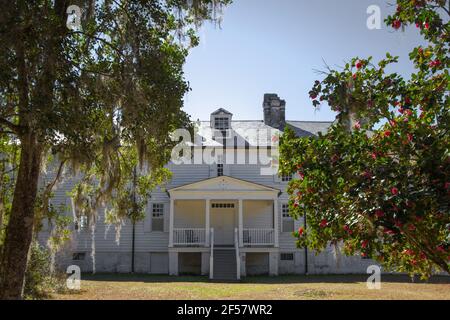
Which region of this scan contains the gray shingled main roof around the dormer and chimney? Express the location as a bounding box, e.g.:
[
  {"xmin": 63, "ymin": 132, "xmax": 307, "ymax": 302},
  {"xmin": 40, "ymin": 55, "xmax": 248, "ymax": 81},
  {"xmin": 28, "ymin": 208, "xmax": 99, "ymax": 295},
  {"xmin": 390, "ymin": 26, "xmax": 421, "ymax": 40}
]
[{"xmin": 187, "ymin": 120, "xmax": 332, "ymax": 147}]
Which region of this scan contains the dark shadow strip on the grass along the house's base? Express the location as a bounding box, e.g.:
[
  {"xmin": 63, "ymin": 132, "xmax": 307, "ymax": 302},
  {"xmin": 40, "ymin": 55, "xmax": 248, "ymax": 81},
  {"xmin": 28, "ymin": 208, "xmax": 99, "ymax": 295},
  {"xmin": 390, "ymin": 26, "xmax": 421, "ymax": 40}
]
[{"xmin": 81, "ymin": 273, "xmax": 450, "ymax": 284}]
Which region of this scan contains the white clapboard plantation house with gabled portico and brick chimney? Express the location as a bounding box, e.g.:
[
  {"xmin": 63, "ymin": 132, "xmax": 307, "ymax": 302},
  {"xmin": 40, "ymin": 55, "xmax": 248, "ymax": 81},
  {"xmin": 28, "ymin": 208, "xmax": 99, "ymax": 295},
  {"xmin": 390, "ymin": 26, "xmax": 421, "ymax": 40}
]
[{"xmin": 40, "ymin": 94, "xmax": 373, "ymax": 280}]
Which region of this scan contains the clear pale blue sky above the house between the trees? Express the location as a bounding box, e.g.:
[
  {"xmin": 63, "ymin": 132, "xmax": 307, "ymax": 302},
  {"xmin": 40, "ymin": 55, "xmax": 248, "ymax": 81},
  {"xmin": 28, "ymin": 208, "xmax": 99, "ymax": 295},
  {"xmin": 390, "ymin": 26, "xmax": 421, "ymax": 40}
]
[{"xmin": 184, "ymin": 0, "xmax": 423, "ymax": 121}]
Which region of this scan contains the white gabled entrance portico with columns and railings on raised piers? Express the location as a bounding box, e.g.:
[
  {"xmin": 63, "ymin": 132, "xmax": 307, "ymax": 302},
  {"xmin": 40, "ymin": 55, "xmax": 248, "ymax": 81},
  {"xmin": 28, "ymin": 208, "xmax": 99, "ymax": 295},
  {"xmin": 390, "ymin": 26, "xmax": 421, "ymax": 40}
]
[{"xmin": 168, "ymin": 176, "xmax": 280, "ymax": 279}]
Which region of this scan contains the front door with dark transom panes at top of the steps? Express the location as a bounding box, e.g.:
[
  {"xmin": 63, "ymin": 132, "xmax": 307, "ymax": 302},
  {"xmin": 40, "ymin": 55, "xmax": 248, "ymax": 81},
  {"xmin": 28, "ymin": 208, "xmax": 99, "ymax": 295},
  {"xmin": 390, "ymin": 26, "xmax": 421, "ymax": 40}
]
[{"xmin": 210, "ymin": 203, "xmax": 236, "ymax": 246}]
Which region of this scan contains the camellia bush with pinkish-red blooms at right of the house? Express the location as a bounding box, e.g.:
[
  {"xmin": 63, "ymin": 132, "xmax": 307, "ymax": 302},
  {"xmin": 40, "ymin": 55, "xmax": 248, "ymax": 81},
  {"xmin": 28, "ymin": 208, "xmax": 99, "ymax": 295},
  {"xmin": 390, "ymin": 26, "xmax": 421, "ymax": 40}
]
[{"xmin": 280, "ymin": 0, "xmax": 450, "ymax": 278}]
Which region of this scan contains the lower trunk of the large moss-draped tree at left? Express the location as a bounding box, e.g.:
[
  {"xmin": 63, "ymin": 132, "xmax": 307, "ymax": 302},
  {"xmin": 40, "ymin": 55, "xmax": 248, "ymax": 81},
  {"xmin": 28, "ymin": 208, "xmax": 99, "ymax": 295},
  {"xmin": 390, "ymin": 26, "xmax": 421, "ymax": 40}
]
[{"xmin": 0, "ymin": 134, "xmax": 42, "ymax": 299}]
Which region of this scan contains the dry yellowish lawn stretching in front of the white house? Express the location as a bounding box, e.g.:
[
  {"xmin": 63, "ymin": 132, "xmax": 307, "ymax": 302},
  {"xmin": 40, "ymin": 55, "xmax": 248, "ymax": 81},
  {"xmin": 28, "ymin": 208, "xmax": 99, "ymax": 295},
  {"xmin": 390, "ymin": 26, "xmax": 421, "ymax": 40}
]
[{"xmin": 52, "ymin": 274, "xmax": 450, "ymax": 300}]
